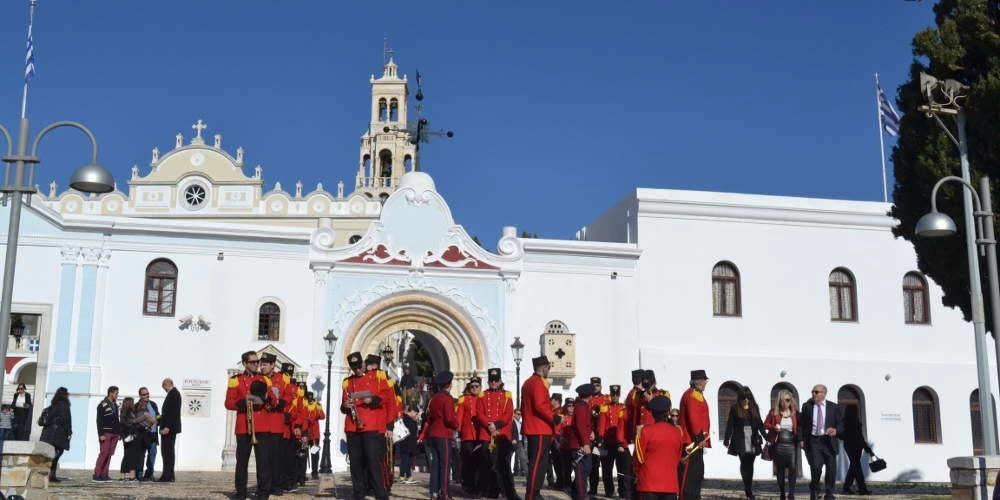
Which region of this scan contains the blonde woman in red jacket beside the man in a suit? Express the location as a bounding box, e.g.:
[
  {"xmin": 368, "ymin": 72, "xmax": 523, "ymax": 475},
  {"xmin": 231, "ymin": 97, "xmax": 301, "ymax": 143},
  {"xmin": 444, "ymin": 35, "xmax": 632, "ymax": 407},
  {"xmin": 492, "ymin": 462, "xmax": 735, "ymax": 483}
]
[{"xmin": 764, "ymin": 390, "xmax": 799, "ymax": 500}]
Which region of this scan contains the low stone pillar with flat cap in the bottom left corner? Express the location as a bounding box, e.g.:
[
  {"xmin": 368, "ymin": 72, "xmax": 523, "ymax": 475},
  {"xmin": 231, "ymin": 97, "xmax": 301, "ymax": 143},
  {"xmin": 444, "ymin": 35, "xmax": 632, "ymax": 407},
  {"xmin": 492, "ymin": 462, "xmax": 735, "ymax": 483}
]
[{"xmin": 0, "ymin": 441, "xmax": 56, "ymax": 500}]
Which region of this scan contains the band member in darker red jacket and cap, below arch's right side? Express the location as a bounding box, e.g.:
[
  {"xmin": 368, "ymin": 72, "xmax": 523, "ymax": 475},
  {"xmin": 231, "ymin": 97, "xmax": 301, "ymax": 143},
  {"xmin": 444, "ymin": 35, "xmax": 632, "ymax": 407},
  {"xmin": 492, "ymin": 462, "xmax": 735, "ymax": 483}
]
[{"xmin": 426, "ymin": 370, "xmax": 458, "ymax": 500}]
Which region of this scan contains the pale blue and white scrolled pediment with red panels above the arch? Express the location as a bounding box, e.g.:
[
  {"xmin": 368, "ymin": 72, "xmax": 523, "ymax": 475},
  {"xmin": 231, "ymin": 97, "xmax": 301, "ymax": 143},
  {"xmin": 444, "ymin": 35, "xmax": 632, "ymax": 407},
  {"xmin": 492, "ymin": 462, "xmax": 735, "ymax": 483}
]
[{"xmin": 310, "ymin": 172, "xmax": 522, "ymax": 275}]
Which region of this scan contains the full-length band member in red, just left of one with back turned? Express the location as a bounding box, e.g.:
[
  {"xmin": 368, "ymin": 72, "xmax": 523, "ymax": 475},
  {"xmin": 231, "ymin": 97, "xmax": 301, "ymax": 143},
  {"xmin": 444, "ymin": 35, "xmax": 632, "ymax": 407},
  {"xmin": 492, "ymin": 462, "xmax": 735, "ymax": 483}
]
[{"xmin": 595, "ymin": 385, "xmax": 632, "ymax": 498}]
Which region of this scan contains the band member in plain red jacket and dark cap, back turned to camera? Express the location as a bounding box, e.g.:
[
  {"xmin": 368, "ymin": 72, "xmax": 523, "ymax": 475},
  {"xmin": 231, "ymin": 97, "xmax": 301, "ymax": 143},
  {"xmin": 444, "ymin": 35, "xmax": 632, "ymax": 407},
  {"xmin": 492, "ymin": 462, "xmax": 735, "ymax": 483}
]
[{"xmin": 633, "ymin": 396, "xmax": 684, "ymax": 500}]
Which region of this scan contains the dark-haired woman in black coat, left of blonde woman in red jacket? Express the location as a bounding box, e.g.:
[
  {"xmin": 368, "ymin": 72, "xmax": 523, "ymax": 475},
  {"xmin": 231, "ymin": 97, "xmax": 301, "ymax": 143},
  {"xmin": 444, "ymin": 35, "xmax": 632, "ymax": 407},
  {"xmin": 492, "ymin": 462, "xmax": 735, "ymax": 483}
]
[{"xmin": 723, "ymin": 386, "xmax": 764, "ymax": 500}]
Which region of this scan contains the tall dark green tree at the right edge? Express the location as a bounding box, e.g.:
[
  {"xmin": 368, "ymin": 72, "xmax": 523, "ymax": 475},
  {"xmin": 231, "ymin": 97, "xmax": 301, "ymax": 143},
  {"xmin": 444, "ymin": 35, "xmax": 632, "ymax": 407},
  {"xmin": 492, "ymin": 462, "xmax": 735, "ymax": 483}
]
[{"xmin": 890, "ymin": 0, "xmax": 1000, "ymax": 330}]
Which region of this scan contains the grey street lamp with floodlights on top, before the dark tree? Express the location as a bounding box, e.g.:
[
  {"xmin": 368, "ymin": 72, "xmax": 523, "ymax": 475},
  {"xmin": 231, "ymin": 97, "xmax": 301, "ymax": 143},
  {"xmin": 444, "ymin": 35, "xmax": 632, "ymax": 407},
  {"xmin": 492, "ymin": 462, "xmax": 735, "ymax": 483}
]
[{"xmin": 915, "ymin": 73, "xmax": 1000, "ymax": 455}]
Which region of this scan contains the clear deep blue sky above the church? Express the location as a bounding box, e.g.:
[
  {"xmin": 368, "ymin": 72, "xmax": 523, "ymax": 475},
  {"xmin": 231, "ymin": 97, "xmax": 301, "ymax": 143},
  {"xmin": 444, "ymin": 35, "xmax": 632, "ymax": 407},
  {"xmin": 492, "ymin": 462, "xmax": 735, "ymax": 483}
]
[{"xmin": 0, "ymin": 0, "xmax": 933, "ymax": 246}]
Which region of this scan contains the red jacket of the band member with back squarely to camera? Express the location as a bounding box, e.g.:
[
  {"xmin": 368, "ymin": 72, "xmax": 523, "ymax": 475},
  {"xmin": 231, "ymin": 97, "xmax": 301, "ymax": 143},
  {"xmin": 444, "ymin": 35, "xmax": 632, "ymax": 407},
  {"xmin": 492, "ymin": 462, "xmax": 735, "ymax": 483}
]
[{"xmin": 632, "ymin": 422, "xmax": 684, "ymax": 493}]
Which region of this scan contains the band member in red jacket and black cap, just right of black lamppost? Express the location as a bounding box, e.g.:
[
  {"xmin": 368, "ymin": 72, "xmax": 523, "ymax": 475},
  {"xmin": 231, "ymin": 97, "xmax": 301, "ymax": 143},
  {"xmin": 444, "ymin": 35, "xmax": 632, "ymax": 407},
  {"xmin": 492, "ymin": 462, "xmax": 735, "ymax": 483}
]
[{"xmin": 340, "ymin": 352, "xmax": 389, "ymax": 500}]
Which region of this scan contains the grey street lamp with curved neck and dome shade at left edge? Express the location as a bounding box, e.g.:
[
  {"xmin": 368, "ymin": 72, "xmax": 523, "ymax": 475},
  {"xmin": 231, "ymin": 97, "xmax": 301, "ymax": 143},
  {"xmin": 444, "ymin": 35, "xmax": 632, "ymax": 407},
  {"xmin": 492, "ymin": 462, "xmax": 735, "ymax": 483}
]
[{"xmin": 0, "ymin": 116, "xmax": 115, "ymax": 412}]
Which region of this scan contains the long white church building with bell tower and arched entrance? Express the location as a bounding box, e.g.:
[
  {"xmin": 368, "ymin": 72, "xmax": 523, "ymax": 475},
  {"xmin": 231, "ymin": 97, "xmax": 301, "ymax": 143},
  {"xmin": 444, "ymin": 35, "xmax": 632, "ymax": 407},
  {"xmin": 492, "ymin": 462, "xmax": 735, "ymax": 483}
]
[{"xmin": 0, "ymin": 56, "xmax": 996, "ymax": 481}]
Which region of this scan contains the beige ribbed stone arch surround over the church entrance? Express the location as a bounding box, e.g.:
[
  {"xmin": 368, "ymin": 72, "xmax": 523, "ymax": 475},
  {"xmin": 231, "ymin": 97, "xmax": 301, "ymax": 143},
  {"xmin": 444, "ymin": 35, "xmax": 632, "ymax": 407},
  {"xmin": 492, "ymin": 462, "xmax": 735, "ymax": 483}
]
[{"xmin": 344, "ymin": 291, "xmax": 486, "ymax": 392}]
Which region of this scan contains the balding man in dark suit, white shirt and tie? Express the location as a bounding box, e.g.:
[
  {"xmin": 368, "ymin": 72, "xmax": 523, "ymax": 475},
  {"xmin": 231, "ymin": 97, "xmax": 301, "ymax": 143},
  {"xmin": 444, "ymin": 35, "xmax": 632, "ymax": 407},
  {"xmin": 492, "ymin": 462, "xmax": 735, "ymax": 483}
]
[{"xmin": 799, "ymin": 384, "xmax": 844, "ymax": 500}]
